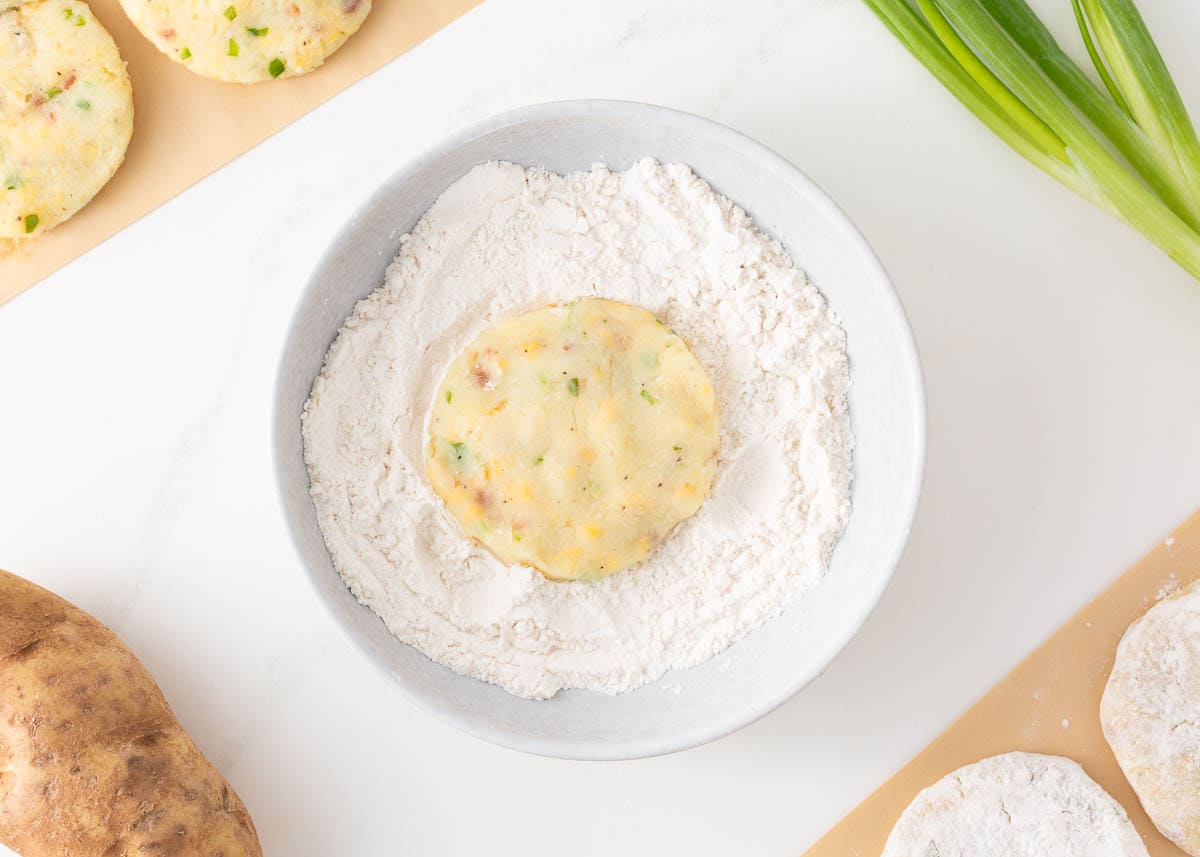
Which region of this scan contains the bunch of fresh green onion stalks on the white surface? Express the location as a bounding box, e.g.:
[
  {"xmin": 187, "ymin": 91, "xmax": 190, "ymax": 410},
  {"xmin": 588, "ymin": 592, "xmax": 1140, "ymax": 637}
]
[{"xmin": 865, "ymin": 0, "xmax": 1200, "ymax": 278}]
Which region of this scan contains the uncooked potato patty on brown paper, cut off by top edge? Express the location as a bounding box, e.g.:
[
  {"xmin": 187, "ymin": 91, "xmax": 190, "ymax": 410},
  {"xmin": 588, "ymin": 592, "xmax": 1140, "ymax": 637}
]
[{"xmin": 121, "ymin": 0, "xmax": 371, "ymax": 83}]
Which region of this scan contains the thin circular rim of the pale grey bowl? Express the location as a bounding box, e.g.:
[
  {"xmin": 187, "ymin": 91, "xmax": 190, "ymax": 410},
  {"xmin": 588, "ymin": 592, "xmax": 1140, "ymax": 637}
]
[{"xmin": 271, "ymin": 98, "xmax": 928, "ymax": 761}]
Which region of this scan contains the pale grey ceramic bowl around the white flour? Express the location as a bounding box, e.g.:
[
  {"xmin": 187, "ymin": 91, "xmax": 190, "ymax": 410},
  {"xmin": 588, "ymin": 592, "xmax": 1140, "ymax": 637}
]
[{"xmin": 275, "ymin": 101, "xmax": 925, "ymax": 759}]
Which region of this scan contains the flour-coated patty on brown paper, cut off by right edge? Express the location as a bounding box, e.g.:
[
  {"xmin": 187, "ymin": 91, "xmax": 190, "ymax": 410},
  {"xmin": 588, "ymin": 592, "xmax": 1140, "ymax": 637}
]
[{"xmin": 1100, "ymin": 575, "xmax": 1200, "ymax": 855}]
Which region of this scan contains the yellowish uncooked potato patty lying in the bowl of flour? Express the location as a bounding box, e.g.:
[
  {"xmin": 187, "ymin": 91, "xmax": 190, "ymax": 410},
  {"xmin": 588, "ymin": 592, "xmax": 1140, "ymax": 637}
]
[{"xmin": 426, "ymin": 299, "xmax": 718, "ymax": 580}]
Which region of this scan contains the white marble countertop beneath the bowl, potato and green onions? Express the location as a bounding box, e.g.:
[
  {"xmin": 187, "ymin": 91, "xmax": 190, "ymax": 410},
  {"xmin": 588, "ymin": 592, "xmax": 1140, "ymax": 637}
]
[{"xmin": 0, "ymin": 0, "xmax": 1200, "ymax": 857}]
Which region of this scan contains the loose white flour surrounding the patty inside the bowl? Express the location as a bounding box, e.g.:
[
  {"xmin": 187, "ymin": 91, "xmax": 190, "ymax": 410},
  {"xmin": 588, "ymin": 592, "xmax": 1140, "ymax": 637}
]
[{"xmin": 304, "ymin": 160, "xmax": 853, "ymax": 699}]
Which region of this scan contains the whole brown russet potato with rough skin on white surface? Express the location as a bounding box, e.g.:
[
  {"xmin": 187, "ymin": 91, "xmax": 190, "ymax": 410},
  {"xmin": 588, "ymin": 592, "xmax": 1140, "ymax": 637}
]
[{"xmin": 0, "ymin": 570, "xmax": 263, "ymax": 857}]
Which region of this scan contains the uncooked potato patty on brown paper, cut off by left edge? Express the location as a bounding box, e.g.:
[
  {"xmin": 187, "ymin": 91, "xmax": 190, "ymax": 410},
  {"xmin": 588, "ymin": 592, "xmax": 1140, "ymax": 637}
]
[{"xmin": 0, "ymin": 0, "xmax": 133, "ymax": 240}]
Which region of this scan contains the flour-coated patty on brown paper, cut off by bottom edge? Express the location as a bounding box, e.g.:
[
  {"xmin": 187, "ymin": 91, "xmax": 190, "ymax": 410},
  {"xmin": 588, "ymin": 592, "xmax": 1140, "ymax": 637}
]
[{"xmin": 883, "ymin": 753, "xmax": 1147, "ymax": 857}]
